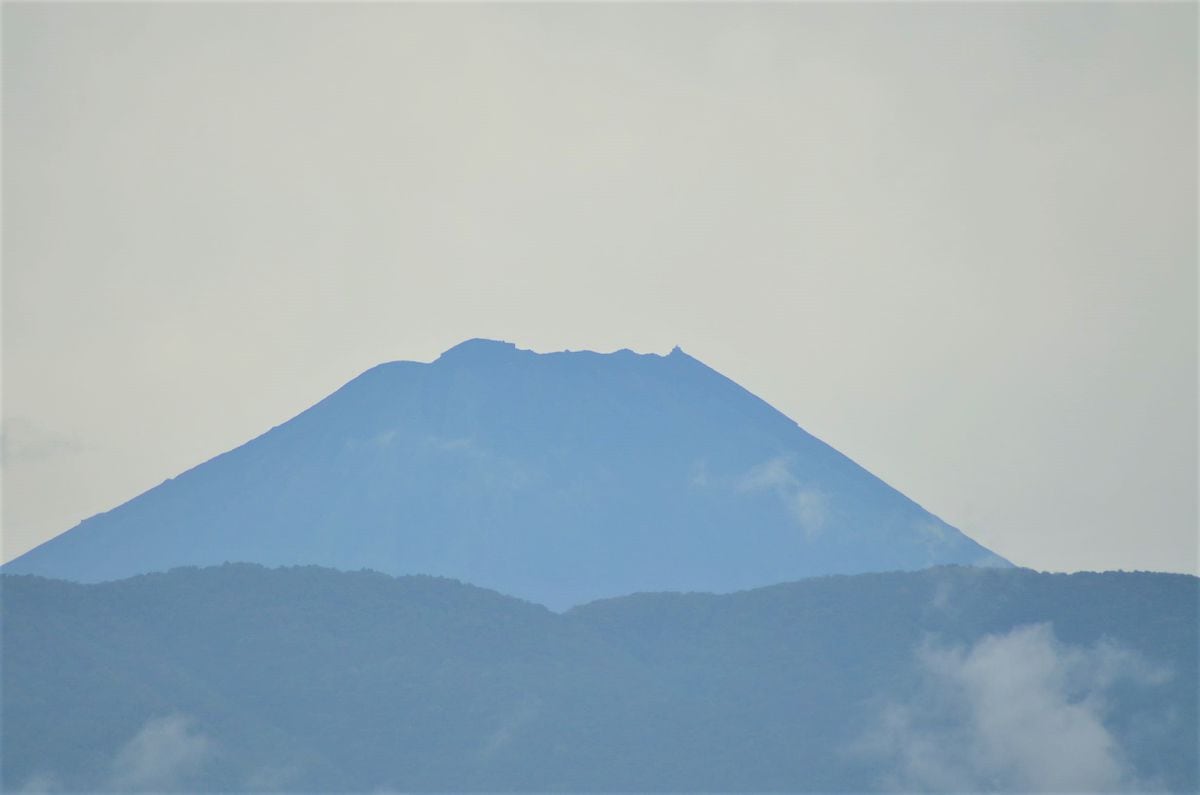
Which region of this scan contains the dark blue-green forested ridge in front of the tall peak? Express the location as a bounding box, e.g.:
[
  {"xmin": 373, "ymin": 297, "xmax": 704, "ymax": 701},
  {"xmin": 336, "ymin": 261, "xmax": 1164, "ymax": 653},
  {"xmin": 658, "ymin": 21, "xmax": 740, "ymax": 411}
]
[{"xmin": 0, "ymin": 564, "xmax": 1200, "ymax": 793}]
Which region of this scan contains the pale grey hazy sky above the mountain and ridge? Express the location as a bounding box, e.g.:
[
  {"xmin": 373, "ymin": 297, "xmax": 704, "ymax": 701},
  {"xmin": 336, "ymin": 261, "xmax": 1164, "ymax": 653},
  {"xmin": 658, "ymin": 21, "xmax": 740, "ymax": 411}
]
[{"xmin": 2, "ymin": 4, "xmax": 1198, "ymax": 572}]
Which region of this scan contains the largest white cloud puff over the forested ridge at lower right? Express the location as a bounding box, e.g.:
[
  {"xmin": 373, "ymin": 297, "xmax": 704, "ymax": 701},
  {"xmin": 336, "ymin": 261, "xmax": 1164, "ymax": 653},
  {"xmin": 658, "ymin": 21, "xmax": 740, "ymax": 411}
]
[{"xmin": 862, "ymin": 623, "xmax": 1169, "ymax": 793}]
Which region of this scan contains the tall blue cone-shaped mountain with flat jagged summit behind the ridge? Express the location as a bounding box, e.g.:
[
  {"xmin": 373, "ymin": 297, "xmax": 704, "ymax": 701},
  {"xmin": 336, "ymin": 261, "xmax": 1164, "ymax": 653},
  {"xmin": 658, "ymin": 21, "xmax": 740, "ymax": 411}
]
[{"xmin": 4, "ymin": 340, "xmax": 1008, "ymax": 609}]
